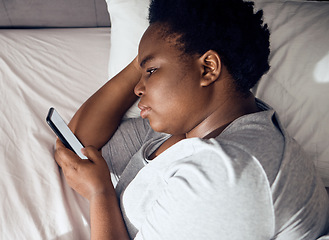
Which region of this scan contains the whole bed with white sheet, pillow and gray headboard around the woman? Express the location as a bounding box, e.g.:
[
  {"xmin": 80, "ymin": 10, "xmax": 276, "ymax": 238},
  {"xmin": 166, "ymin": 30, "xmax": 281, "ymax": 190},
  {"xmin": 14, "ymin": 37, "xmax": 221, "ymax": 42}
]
[{"xmin": 0, "ymin": 0, "xmax": 329, "ymax": 240}]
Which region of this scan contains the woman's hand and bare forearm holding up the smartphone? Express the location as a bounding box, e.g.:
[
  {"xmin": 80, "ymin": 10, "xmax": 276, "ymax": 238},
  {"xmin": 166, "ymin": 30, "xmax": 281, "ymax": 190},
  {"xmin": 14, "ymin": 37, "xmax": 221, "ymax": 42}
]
[{"xmin": 55, "ymin": 139, "xmax": 129, "ymax": 240}]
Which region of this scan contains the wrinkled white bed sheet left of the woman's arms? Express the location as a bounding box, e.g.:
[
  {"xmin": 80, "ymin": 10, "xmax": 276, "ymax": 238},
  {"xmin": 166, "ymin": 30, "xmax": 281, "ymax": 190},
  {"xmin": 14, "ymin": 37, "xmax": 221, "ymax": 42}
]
[{"xmin": 0, "ymin": 28, "xmax": 110, "ymax": 240}]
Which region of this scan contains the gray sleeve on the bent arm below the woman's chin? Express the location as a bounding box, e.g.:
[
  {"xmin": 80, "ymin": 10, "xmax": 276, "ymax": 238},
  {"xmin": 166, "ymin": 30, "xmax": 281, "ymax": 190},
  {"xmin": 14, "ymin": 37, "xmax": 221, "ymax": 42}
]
[{"xmin": 102, "ymin": 118, "xmax": 153, "ymax": 185}]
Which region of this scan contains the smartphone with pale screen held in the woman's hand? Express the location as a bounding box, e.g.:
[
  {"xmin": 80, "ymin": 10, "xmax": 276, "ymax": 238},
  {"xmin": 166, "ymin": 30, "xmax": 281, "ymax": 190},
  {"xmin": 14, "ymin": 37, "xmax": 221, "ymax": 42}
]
[{"xmin": 46, "ymin": 107, "xmax": 87, "ymax": 159}]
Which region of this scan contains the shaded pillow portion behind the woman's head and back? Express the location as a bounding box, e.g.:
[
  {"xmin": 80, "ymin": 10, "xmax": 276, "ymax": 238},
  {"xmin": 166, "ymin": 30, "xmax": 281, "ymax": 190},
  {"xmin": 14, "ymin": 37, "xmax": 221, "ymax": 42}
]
[{"xmin": 255, "ymin": 1, "xmax": 329, "ymax": 187}]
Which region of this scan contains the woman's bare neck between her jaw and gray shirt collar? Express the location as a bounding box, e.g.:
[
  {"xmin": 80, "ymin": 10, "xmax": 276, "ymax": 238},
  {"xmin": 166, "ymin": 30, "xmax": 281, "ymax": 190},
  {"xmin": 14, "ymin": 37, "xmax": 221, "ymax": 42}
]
[{"xmin": 186, "ymin": 93, "xmax": 260, "ymax": 139}]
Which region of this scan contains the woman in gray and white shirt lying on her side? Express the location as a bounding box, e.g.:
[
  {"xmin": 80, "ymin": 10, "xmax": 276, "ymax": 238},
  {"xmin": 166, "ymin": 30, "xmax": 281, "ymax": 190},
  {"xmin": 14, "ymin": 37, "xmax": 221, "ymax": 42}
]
[{"xmin": 55, "ymin": 0, "xmax": 329, "ymax": 240}]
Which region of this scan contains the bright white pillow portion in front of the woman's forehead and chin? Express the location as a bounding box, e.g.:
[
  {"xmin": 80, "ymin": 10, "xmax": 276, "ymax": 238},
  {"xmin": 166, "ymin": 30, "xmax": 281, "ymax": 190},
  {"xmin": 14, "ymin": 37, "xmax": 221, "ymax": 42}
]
[{"xmin": 106, "ymin": 0, "xmax": 150, "ymax": 117}]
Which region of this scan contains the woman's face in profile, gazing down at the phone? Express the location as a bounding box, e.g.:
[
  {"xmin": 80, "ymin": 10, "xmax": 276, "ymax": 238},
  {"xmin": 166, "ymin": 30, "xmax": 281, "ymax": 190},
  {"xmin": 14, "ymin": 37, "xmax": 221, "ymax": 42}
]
[{"xmin": 135, "ymin": 24, "xmax": 209, "ymax": 135}]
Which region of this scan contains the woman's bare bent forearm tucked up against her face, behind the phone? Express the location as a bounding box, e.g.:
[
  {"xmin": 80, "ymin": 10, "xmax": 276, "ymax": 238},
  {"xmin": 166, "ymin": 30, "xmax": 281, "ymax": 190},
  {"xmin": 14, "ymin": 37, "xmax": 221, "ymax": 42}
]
[{"xmin": 69, "ymin": 58, "xmax": 141, "ymax": 149}]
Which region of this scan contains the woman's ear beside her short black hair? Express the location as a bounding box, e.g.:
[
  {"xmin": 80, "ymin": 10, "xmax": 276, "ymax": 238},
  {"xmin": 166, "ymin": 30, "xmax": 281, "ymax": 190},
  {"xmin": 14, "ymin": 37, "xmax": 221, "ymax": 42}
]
[{"xmin": 199, "ymin": 50, "xmax": 222, "ymax": 87}]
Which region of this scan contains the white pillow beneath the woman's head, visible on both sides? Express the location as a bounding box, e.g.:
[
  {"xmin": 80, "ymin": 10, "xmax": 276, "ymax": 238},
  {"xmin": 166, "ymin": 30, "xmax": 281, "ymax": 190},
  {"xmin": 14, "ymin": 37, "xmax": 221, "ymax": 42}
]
[{"xmin": 104, "ymin": 0, "xmax": 329, "ymax": 186}]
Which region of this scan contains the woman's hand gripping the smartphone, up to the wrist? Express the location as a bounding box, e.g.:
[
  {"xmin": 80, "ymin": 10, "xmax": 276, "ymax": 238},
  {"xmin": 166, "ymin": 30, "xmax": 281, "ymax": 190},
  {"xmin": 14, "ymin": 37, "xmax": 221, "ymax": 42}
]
[{"xmin": 55, "ymin": 139, "xmax": 115, "ymax": 201}]
